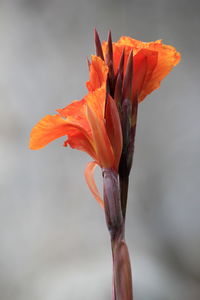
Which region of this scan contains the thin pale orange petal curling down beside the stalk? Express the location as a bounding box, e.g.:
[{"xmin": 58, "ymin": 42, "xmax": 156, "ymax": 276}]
[{"xmin": 85, "ymin": 161, "xmax": 104, "ymax": 208}]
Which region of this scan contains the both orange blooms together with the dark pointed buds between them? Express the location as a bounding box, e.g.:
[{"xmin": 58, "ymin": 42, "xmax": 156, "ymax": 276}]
[{"xmin": 30, "ymin": 30, "xmax": 180, "ymax": 209}]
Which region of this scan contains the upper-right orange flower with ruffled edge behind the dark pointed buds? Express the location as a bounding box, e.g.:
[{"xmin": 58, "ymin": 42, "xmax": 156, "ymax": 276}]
[{"xmin": 99, "ymin": 36, "xmax": 181, "ymax": 102}]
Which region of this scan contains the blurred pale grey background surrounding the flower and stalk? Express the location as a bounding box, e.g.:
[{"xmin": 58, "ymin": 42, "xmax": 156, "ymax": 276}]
[{"xmin": 0, "ymin": 0, "xmax": 200, "ymax": 300}]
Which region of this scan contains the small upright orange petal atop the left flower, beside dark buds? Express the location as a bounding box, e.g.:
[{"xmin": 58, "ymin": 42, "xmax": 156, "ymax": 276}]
[{"xmin": 86, "ymin": 55, "xmax": 108, "ymax": 92}]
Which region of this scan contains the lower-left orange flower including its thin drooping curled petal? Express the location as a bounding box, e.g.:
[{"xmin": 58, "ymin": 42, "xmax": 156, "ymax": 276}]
[{"xmin": 30, "ymin": 56, "xmax": 122, "ymax": 205}]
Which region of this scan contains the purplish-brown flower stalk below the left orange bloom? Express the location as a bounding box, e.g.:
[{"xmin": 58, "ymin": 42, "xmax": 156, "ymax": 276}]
[{"xmin": 102, "ymin": 169, "xmax": 133, "ymax": 300}]
